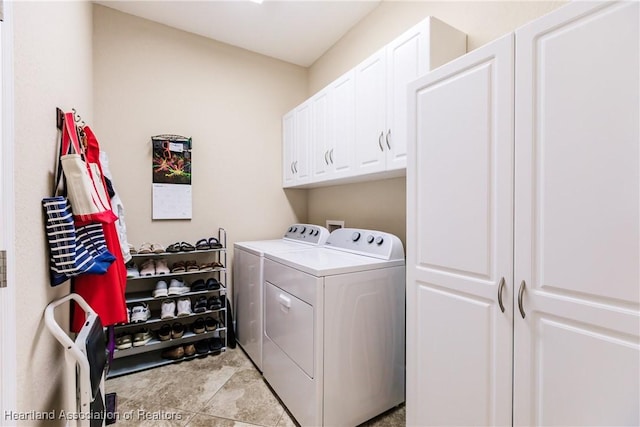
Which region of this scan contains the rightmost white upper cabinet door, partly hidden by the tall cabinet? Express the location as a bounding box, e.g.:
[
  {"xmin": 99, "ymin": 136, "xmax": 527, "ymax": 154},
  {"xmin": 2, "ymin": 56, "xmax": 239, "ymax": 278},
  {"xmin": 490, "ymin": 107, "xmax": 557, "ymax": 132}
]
[{"xmin": 384, "ymin": 22, "xmax": 429, "ymax": 169}]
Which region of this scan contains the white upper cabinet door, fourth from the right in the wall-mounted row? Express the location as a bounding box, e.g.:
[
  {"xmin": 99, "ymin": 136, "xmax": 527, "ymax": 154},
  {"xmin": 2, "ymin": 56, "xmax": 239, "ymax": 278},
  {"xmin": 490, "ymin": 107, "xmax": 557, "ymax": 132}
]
[{"xmin": 311, "ymin": 90, "xmax": 332, "ymax": 182}]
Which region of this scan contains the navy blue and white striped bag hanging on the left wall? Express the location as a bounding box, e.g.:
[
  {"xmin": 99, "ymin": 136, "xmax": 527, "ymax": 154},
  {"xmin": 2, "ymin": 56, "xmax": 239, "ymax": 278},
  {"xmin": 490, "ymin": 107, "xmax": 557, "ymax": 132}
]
[{"xmin": 42, "ymin": 196, "xmax": 115, "ymax": 286}]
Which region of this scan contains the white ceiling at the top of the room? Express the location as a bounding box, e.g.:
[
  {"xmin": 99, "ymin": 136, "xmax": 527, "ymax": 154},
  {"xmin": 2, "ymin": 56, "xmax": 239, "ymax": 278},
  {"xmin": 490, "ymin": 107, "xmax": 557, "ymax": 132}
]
[{"xmin": 95, "ymin": 0, "xmax": 381, "ymax": 67}]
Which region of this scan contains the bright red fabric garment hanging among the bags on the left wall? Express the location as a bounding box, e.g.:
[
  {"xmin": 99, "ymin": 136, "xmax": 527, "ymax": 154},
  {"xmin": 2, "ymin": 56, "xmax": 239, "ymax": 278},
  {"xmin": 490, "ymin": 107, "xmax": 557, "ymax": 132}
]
[{"xmin": 72, "ymin": 126, "xmax": 127, "ymax": 332}]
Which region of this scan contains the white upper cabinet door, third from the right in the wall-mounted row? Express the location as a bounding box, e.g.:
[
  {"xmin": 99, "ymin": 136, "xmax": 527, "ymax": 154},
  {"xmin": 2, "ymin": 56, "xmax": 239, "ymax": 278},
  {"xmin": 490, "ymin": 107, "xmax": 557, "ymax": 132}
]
[{"xmin": 329, "ymin": 71, "xmax": 356, "ymax": 178}]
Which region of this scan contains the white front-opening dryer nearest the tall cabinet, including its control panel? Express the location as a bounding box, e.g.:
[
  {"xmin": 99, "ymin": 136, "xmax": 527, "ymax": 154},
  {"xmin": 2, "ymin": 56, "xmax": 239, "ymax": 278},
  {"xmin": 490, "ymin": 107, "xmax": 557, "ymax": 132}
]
[{"xmin": 262, "ymin": 228, "xmax": 405, "ymax": 427}]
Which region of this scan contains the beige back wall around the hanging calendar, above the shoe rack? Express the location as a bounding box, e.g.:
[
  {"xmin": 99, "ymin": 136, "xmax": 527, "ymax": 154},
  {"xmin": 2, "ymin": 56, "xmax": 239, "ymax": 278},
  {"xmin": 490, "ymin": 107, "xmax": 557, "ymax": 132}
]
[{"xmin": 93, "ymin": 6, "xmax": 307, "ymax": 254}]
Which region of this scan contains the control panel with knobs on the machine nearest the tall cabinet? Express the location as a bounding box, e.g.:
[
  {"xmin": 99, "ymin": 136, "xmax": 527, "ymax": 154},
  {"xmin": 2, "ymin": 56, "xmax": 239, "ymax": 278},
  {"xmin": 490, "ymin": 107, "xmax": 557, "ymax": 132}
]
[{"xmin": 325, "ymin": 228, "xmax": 404, "ymax": 260}]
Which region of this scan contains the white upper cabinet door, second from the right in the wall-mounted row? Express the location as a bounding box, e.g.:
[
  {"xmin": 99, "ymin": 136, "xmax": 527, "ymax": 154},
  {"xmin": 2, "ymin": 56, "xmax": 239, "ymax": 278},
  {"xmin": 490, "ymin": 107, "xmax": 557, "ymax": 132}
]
[{"xmin": 355, "ymin": 49, "xmax": 387, "ymax": 174}]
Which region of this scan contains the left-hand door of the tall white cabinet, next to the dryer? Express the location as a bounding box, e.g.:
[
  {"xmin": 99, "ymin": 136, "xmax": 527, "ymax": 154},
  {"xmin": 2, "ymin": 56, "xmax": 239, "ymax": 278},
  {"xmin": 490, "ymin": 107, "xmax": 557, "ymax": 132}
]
[{"xmin": 406, "ymin": 35, "xmax": 513, "ymax": 426}]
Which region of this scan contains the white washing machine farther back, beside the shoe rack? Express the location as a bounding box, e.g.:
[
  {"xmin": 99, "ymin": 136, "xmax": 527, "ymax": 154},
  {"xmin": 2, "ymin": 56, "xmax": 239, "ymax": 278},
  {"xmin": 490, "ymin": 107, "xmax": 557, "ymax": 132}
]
[{"xmin": 232, "ymin": 224, "xmax": 329, "ymax": 370}]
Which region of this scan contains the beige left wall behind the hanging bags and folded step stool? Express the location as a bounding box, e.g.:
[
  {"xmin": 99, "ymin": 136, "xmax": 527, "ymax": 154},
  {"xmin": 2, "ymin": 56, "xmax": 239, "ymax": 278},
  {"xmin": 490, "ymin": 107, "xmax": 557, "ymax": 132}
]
[{"xmin": 13, "ymin": 2, "xmax": 93, "ymax": 425}]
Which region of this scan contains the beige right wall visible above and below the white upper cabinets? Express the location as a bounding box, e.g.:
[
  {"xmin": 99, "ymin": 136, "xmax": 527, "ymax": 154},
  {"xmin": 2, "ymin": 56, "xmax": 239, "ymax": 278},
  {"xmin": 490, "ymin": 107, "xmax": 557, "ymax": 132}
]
[{"xmin": 308, "ymin": 0, "xmax": 565, "ymax": 246}]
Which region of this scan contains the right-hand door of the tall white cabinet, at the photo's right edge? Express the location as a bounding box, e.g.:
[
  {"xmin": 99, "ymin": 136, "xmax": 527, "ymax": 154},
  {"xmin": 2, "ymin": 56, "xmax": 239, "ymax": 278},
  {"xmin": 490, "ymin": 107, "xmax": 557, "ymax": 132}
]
[{"xmin": 513, "ymin": 2, "xmax": 640, "ymax": 426}]
